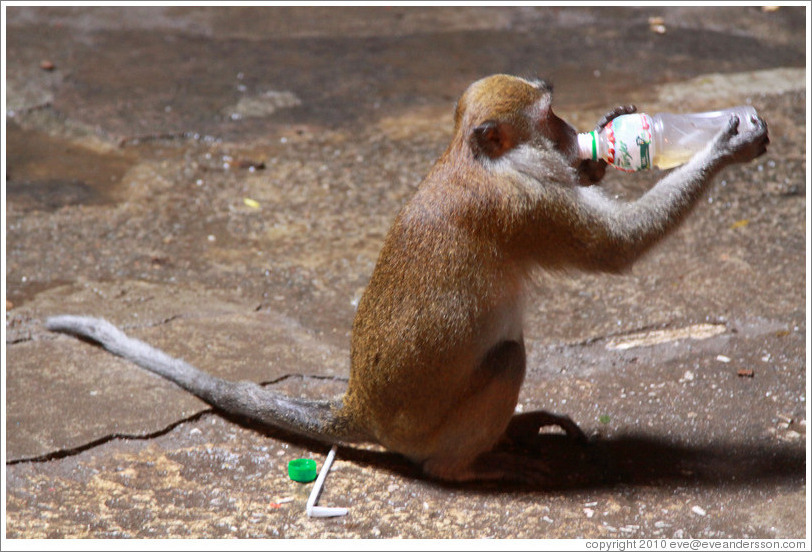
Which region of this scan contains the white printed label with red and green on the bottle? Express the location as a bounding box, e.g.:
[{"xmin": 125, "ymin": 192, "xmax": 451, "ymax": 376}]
[{"xmin": 606, "ymin": 113, "xmax": 651, "ymax": 172}]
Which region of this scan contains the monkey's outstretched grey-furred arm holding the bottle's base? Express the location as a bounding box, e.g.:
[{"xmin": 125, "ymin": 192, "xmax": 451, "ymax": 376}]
[{"xmin": 570, "ymin": 113, "xmax": 769, "ymax": 272}]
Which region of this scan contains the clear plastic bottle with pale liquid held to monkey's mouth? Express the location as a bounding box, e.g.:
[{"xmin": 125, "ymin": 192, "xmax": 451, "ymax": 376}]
[{"xmin": 578, "ymin": 106, "xmax": 756, "ymax": 172}]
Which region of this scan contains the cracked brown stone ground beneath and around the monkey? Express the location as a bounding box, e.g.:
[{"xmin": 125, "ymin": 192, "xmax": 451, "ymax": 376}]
[{"xmin": 4, "ymin": 6, "xmax": 809, "ymax": 539}]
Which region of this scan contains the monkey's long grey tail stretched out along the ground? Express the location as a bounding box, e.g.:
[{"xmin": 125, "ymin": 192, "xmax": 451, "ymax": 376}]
[{"xmin": 45, "ymin": 315, "xmax": 370, "ymax": 443}]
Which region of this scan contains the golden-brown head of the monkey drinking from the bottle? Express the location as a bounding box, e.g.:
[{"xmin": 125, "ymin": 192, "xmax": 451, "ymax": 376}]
[{"xmin": 454, "ymin": 75, "xmax": 580, "ymax": 167}]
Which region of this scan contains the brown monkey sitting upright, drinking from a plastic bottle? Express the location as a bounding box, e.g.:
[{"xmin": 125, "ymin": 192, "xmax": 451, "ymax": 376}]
[{"xmin": 46, "ymin": 74, "xmax": 769, "ymax": 482}]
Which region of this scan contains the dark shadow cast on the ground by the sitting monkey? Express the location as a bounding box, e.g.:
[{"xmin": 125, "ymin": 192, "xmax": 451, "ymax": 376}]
[{"xmin": 243, "ymin": 416, "xmax": 806, "ymax": 492}]
